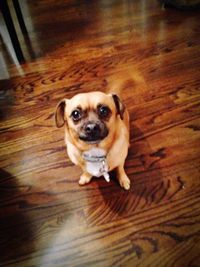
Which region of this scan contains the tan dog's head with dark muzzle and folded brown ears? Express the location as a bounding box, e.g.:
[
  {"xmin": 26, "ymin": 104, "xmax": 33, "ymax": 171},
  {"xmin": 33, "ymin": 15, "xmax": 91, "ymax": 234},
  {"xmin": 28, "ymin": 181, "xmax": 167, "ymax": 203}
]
[{"xmin": 55, "ymin": 92, "xmax": 124, "ymax": 149}]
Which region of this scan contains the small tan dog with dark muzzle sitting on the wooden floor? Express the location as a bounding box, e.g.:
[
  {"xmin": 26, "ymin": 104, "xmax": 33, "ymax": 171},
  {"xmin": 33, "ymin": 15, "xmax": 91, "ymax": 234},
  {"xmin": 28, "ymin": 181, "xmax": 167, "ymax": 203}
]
[{"xmin": 55, "ymin": 92, "xmax": 130, "ymax": 190}]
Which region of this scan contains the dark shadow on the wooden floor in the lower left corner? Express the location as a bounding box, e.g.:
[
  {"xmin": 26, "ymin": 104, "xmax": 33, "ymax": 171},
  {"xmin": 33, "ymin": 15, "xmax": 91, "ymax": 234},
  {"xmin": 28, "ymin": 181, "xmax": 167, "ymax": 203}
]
[{"xmin": 0, "ymin": 169, "xmax": 34, "ymax": 266}]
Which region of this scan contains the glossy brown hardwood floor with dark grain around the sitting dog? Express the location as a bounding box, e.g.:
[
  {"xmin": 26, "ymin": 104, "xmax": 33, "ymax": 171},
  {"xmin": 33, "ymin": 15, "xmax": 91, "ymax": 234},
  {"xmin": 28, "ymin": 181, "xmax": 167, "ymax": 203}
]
[{"xmin": 0, "ymin": 0, "xmax": 200, "ymax": 267}]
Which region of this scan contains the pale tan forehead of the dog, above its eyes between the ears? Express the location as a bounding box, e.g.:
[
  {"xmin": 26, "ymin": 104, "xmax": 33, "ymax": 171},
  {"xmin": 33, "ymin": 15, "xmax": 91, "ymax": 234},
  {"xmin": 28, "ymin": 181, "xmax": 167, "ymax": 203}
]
[{"xmin": 67, "ymin": 92, "xmax": 115, "ymax": 112}]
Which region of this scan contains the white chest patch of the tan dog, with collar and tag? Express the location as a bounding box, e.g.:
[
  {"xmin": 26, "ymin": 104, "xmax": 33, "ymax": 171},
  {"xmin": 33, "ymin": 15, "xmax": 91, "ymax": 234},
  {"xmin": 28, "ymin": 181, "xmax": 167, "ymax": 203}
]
[{"xmin": 82, "ymin": 148, "xmax": 110, "ymax": 182}]
